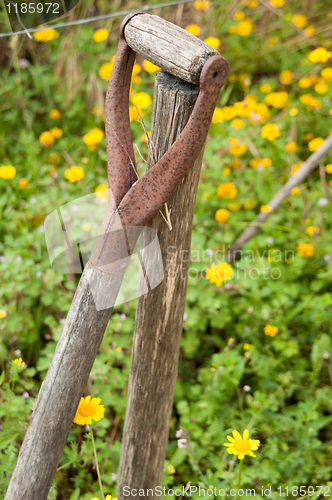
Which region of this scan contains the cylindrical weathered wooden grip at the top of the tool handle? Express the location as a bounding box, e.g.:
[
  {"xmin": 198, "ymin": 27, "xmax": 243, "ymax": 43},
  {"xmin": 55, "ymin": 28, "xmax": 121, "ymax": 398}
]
[{"xmin": 123, "ymin": 13, "xmax": 219, "ymax": 85}]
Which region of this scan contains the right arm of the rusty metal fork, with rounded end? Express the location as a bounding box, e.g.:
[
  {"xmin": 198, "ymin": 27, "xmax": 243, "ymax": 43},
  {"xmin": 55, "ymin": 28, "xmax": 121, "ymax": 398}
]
[{"xmin": 118, "ymin": 55, "xmax": 228, "ymax": 226}]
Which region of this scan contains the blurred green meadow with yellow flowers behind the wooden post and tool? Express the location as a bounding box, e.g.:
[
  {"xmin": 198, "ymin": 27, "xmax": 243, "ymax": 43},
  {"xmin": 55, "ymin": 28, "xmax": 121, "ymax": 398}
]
[{"xmin": 0, "ymin": 0, "xmax": 332, "ymax": 500}]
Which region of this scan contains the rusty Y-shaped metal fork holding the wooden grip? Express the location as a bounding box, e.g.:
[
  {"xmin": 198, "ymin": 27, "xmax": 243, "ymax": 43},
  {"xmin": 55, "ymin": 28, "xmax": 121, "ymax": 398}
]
[{"xmin": 90, "ymin": 13, "xmax": 228, "ymax": 273}]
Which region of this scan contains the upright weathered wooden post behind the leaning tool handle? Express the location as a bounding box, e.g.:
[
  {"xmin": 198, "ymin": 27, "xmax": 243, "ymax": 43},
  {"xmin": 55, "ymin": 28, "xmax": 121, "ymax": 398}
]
[{"xmin": 117, "ymin": 72, "xmax": 203, "ymax": 500}]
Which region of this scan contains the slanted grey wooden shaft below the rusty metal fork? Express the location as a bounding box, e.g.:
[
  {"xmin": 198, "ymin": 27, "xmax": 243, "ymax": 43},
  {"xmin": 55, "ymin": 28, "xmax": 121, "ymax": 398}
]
[{"xmin": 5, "ymin": 263, "xmax": 122, "ymax": 500}]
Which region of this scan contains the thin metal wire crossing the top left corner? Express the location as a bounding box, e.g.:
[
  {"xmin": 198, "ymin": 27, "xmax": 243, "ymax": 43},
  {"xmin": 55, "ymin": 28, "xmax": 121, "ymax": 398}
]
[{"xmin": 0, "ymin": 0, "xmax": 194, "ymax": 38}]
